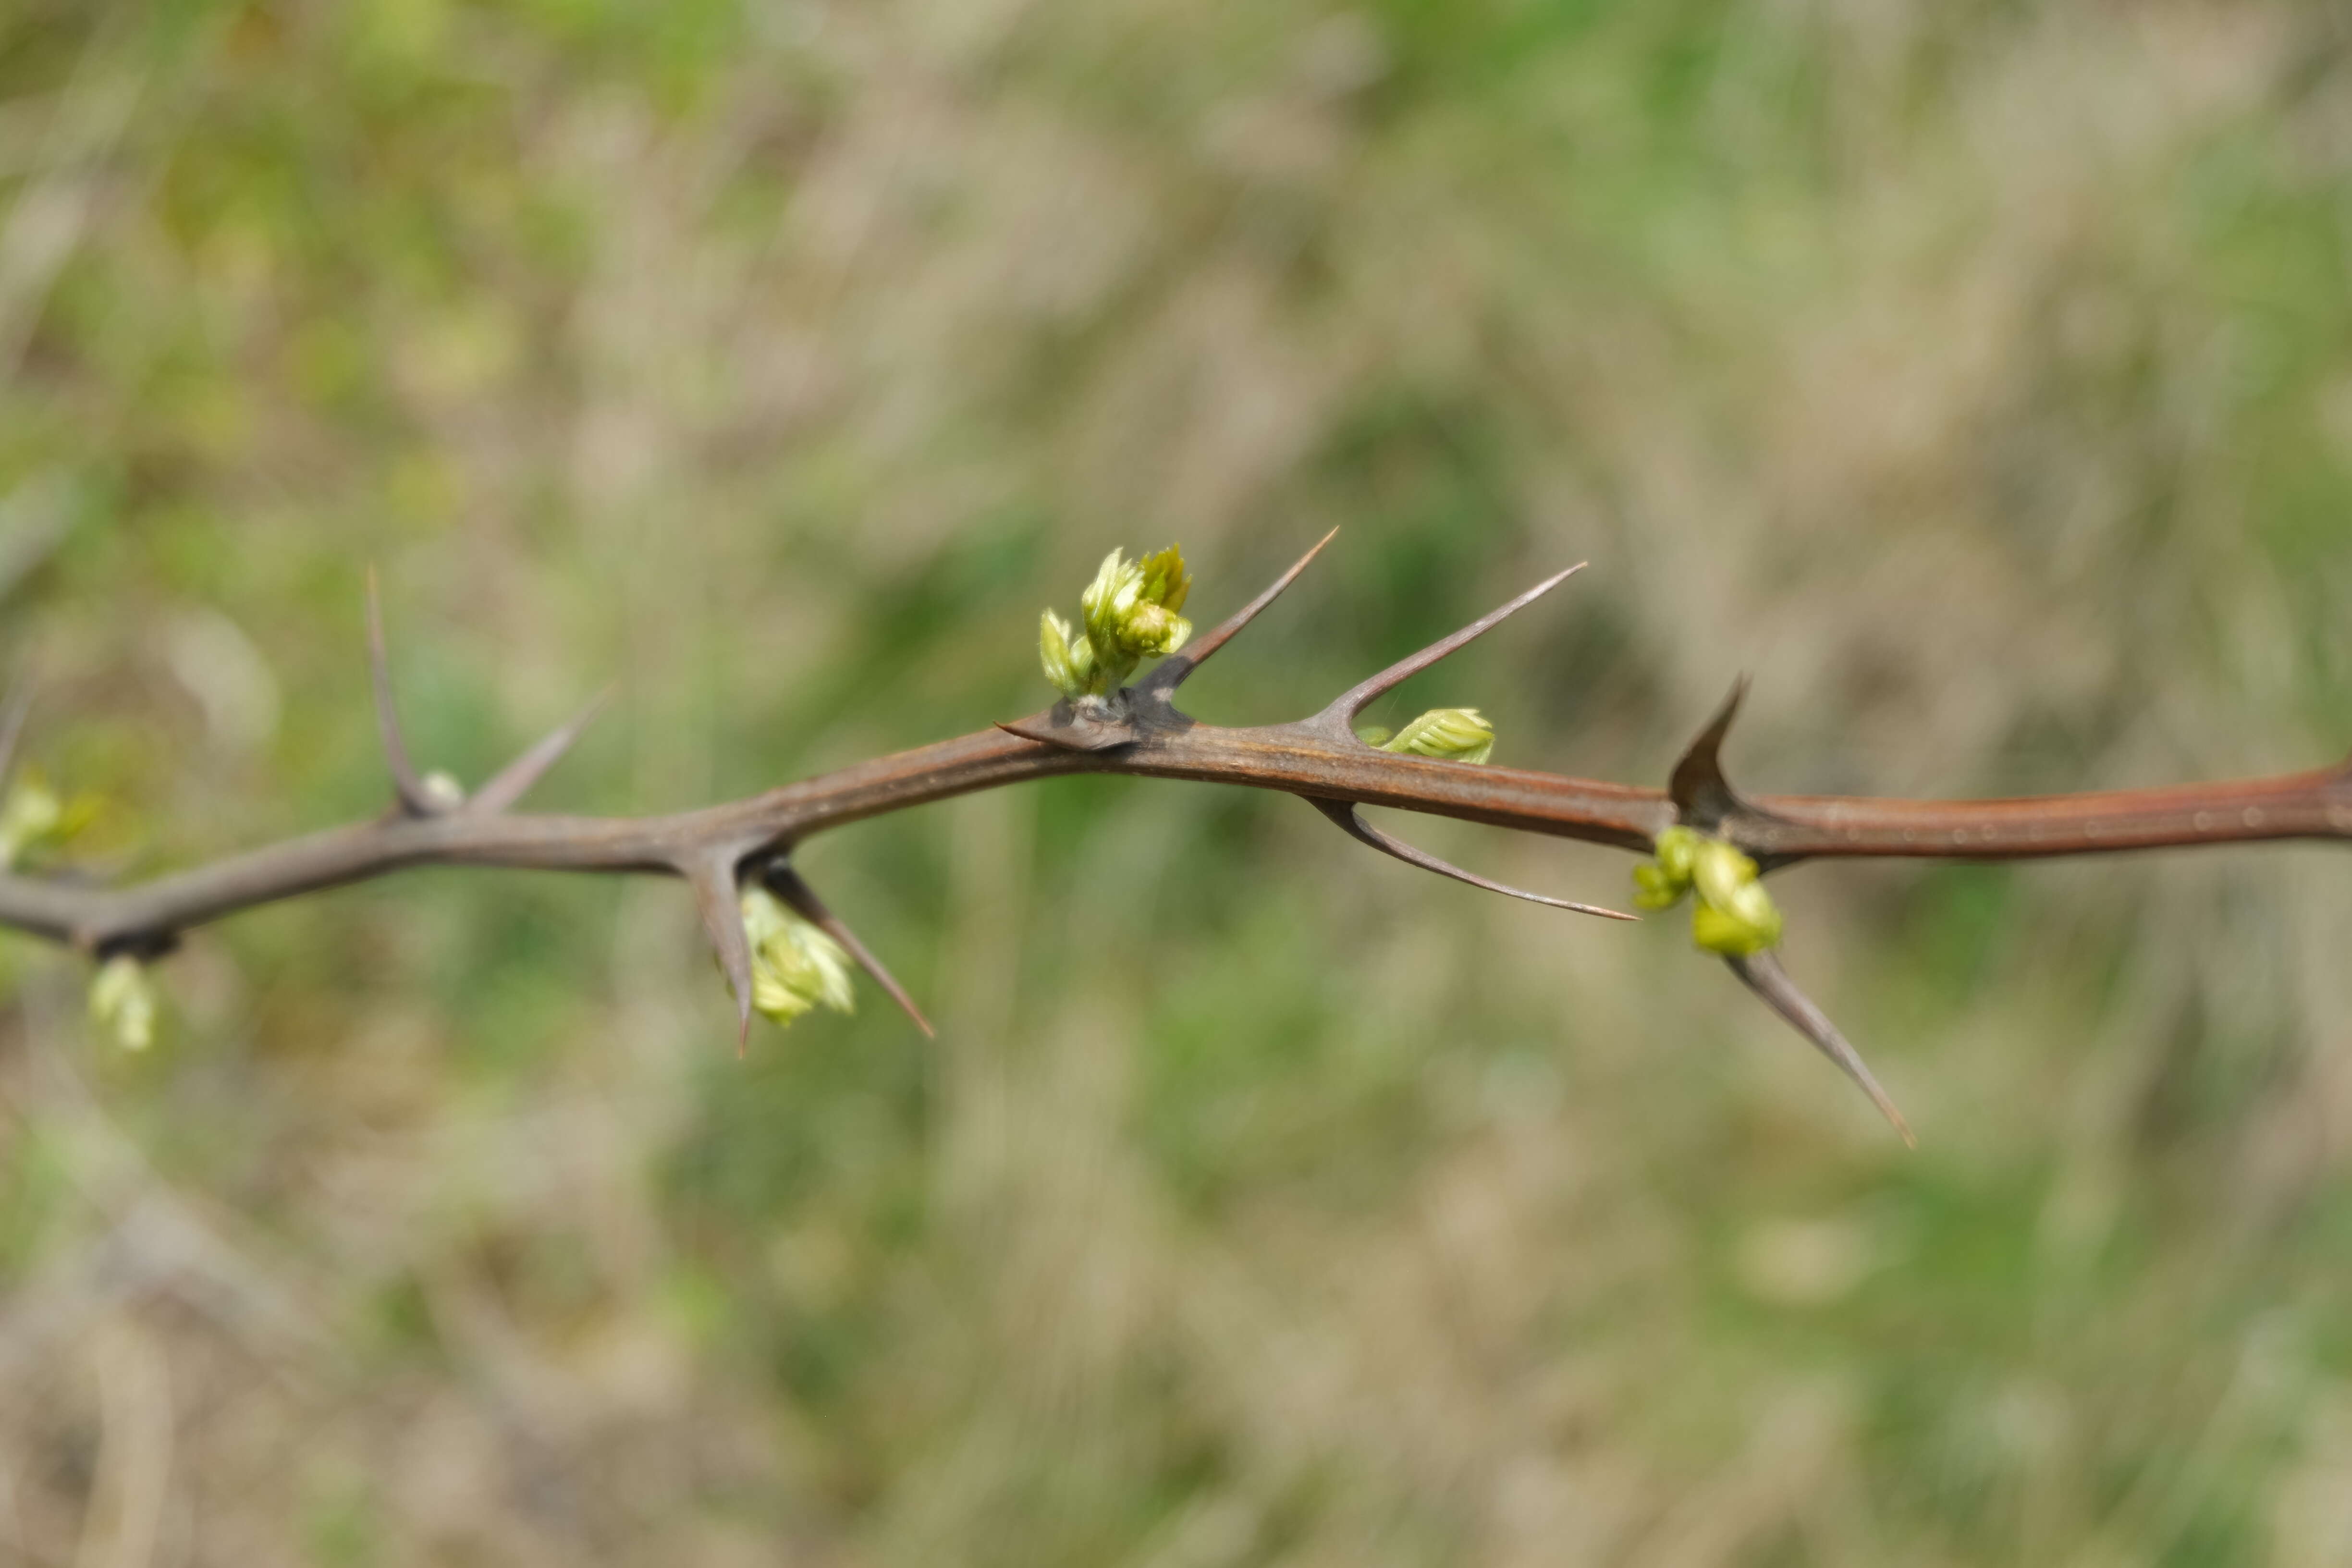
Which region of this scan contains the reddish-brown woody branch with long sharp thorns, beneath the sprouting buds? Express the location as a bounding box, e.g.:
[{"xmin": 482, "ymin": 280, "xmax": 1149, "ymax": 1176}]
[{"xmin": 0, "ymin": 534, "xmax": 2352, "ymax": 1138}]
